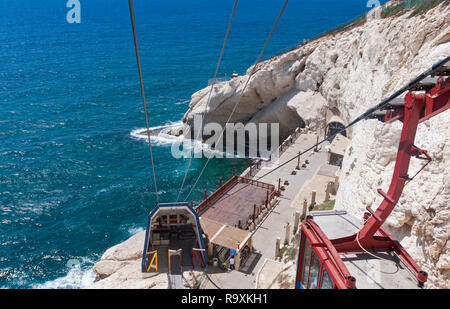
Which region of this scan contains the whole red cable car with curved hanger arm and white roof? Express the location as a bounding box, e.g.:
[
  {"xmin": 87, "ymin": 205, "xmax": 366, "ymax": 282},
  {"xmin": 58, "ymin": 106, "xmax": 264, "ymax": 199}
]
[{"xmin": 295, "ymin": 58, "xmax": 450, "ymax": 289}]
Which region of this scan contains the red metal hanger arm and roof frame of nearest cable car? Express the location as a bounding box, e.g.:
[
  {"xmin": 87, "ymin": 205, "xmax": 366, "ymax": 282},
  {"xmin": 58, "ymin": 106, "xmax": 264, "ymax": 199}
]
[{"xmin": 297, "ymin": 77, "xmax": 450, "ymax": 288}]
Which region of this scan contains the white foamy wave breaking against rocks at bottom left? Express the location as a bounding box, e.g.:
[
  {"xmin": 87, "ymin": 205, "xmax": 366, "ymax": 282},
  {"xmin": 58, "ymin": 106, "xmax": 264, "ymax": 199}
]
[{"xmin": 32, "ymin": 258, "xmax": 95, "ymax": 289}]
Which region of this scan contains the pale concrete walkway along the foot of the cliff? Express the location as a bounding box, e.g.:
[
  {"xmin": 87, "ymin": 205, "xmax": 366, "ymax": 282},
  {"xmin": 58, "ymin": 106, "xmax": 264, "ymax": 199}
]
[{"xmin": 202, "ymin": 134, "xmax": 327, "ymax": 289}]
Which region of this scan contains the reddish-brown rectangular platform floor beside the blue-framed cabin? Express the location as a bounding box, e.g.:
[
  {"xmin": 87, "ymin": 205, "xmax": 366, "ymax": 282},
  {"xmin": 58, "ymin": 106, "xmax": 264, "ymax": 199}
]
[{"xmin": 202, "ymin": 183, "xmax": 267, "ymax": 227}]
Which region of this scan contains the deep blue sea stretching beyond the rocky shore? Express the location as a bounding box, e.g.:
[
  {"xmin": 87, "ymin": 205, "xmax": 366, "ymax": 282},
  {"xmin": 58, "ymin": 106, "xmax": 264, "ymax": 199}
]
[{"xmin": 0, "ymin": 0, "xmax": 382, "ymax": 288}]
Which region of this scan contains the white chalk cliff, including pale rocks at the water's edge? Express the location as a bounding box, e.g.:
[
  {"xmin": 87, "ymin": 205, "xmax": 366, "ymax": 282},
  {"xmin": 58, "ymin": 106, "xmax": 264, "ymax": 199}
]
[{"xmin": 89, "ymin": 1, "xmax": 450, "ymax": 288}]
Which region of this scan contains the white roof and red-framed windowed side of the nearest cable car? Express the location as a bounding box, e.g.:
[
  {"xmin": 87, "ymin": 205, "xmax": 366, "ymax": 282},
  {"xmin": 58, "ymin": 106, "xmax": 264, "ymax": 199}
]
[{"xmin": 296, "ymin": 211, "xmax": 419, "ymax": 289}]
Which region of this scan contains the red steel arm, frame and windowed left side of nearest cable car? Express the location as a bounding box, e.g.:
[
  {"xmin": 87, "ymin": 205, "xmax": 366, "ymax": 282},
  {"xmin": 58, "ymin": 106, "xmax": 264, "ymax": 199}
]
[{"xmin": 296, "ymin": 72, "xmax": 450, "ymax": 289}]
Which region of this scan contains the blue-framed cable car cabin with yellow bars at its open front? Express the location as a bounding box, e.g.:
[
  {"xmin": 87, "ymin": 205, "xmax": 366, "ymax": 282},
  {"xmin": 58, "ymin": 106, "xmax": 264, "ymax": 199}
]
[{"xmin": 142, "ymin": 203, "xmax": 207, "ymax": 277}]
